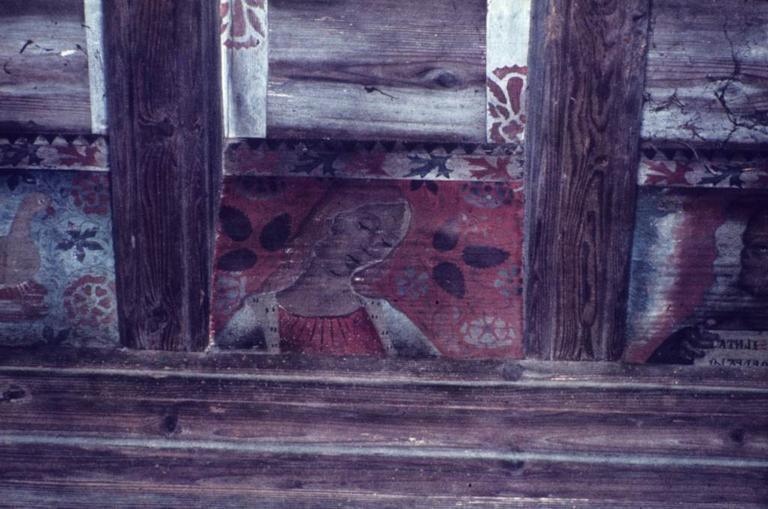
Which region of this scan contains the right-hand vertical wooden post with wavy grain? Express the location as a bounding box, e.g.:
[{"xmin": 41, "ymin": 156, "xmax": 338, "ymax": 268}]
[{"xmin": 526, "ymin": 0, "xmax": 650, "ymax": 360}]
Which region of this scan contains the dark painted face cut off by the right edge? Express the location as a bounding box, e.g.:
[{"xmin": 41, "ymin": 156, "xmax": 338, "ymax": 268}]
[{"xmin": 739, "ymin": 212, "xmax": 768, "ymax": 297}]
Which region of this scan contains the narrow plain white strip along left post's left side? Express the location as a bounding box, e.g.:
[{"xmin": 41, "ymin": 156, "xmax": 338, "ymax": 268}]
[{"xmin": 84, "ymin": 0, "xmax": 107, "ymax": 134}]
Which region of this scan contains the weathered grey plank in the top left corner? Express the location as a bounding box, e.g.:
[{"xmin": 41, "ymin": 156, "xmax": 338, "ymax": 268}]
[{"xmin": 0, "ymin": 0, "xmax": 91, "ymax": 133}]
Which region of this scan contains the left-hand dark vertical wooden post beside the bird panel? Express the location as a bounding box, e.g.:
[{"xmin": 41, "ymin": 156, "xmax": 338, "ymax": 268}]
[{"xmin": 104, "ymin": 0, "xmax": 221, "ymax": 350}]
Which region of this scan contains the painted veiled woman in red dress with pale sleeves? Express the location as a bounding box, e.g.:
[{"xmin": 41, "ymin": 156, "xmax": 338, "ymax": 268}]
[{"xmin": 215, "ymin": 183, "xmax": 438, "ymax": 358}]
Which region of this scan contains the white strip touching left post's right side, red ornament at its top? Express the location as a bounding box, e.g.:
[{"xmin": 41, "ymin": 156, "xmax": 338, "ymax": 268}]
[{"xmin": 220, "ymin": 0, "xmax": 269, "ymax": 138}]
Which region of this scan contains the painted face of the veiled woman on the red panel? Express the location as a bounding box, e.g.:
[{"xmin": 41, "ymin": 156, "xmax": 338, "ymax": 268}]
[{"xmin": 315, "ymin": 203, "xmax": 406, "ymax": 277}]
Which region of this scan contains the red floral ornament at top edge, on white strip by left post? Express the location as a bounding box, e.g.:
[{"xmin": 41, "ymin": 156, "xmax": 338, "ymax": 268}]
[{"xmin": 219, "ymin": 0, "xmax": 266, "ymax": 49}]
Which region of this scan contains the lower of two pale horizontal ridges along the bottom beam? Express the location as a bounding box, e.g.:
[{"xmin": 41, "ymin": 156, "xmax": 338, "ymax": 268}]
[{"xmin": 0, "ymin": 433, "xmax": 768, "ymax": 469}]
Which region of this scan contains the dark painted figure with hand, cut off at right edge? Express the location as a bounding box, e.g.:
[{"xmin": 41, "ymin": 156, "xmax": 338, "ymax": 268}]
[{"xmin": 647, "ymin": 208, "xmax": 768, "ymax": 364}]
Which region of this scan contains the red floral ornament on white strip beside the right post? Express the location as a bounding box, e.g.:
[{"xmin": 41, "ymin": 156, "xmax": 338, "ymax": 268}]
[{"xmin": 487, "ymin": 65, "xmax": 528, "ymax": 144}]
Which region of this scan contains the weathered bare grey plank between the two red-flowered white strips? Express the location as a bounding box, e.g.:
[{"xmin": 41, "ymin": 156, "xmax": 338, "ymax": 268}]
[{"xmin": 267, "ymin": 0, "xmax": 486, "ymax": 141}]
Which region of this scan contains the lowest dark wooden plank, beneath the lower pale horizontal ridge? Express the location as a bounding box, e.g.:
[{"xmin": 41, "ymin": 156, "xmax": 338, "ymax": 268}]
[{"xmin": 0, "ymin": 437, "xmax": 768, "ymax": 507}]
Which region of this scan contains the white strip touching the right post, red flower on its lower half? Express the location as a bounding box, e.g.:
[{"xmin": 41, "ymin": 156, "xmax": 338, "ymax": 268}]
[{"xmin": 485, "ymin": 0, "xmax": 531, "ymax": 143}]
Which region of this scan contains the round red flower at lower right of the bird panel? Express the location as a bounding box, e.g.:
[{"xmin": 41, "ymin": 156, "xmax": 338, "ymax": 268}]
[{"xmin": 64, "ymin": 274, "xmax": 117, "ymax": 327}]
